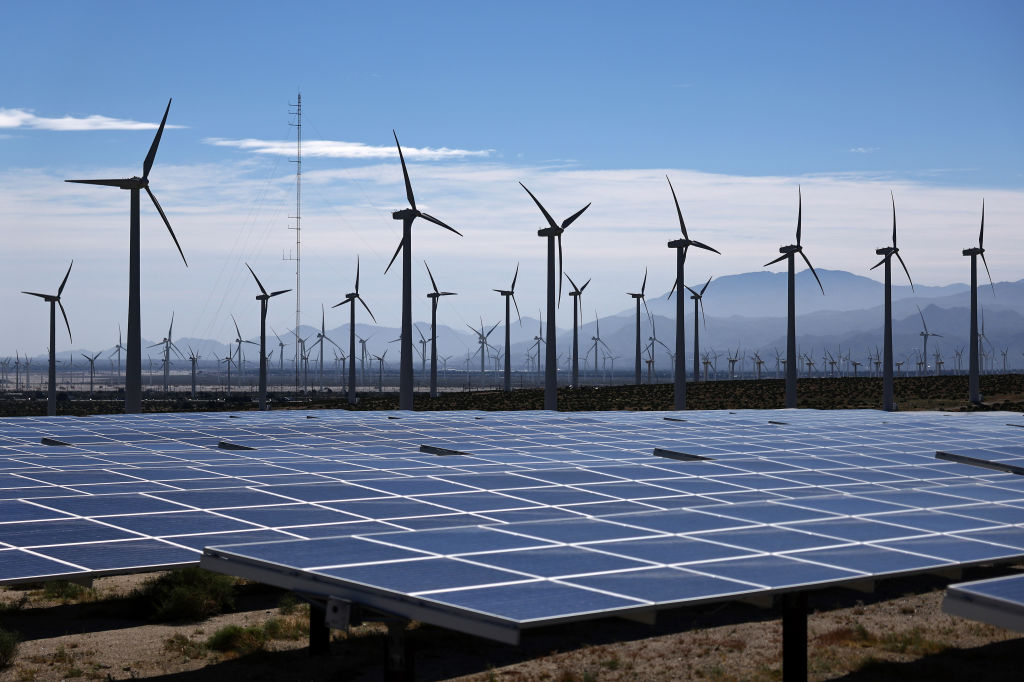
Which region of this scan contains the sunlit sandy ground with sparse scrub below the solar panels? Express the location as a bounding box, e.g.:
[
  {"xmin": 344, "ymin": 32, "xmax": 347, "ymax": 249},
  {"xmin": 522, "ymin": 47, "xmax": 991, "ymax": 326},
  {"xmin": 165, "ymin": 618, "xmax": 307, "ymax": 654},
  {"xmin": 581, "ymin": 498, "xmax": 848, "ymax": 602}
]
[{"xmin": 0, "ymin": 568, "xmax": 1024, "ymax": 682}]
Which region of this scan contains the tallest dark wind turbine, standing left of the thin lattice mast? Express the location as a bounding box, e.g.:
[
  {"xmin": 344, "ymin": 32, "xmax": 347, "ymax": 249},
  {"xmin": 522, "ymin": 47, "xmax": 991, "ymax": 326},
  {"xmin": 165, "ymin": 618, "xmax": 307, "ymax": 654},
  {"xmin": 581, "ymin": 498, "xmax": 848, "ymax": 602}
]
[{"xmin": 65, "ymin": 99, "xmax": 188, "ymax": 414}]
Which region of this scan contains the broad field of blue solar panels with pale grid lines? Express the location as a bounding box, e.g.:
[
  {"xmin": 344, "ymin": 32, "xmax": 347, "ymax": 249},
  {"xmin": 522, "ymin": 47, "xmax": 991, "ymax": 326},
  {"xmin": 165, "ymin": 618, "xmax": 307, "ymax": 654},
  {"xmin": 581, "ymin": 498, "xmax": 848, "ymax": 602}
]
[{"xmin": 0, "ymin": 411, "xmax": 1024, "ymax": 638}]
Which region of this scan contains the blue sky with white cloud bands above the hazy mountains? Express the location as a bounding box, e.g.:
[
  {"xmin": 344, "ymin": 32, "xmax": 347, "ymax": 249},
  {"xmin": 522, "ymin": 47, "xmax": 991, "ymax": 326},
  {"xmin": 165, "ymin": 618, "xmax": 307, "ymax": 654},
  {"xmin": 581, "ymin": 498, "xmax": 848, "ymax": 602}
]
[{"xmin": 0, "ymin": 2, "xmax": 1024, "ymax": 353}]
